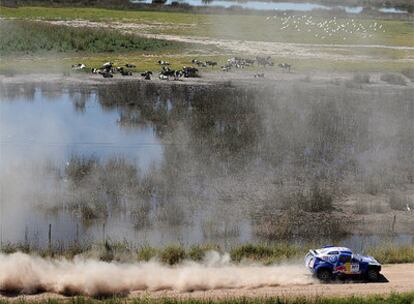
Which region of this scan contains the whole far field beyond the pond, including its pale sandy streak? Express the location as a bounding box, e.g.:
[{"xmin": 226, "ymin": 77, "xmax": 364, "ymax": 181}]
[{"xmin": 0, "ymin": 7, "xmax": 414, "ymax": 74}]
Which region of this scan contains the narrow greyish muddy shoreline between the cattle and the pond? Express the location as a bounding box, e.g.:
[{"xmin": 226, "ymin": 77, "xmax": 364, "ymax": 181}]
[{"xmin": 0, "ymin": 71, "xmax": 414, "ymax": 89}]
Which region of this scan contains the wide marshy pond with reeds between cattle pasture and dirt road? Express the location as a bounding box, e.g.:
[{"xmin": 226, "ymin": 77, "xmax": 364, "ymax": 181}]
[{"xmin": 0, "ymin": 82, "xmax": 414, "ymax": 248}]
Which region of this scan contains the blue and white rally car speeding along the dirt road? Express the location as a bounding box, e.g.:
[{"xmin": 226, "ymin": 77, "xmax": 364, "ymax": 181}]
[{"xmin": 305, "ymin": 246, "xmax": 381, "ymax": 282}]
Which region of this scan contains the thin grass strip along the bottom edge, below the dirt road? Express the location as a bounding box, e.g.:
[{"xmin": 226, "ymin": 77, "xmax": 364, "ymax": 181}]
[{"xmin": 0, "ymin": 293, "xmax": 414, "ymax": 304}]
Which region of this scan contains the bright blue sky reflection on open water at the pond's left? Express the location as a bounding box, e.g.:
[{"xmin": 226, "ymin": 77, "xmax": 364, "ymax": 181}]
[{"xmin": 0, "ymin": 87, "xmax": 162, "ymax": 167}]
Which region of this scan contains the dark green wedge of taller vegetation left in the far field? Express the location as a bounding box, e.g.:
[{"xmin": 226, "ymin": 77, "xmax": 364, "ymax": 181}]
[{"xmin": 0, "ymin": 21, "xmax": 188, "ymax": 55}]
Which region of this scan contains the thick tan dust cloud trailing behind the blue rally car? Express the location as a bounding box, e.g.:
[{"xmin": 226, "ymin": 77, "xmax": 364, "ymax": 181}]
[{"xmin": 0, "ymin": 251, "xmax": 314, "ymax": 296}]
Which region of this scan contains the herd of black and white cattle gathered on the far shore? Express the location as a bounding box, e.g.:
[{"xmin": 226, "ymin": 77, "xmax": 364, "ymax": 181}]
[{"xmin": 72, "ymin": 56, "xmax": 292, "ymax": 80}]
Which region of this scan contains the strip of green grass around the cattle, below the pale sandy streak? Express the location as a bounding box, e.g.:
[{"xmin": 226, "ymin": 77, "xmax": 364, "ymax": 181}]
[{"xmin": 0, "ymin": 51, "xmax": 414, "ymax": 75}]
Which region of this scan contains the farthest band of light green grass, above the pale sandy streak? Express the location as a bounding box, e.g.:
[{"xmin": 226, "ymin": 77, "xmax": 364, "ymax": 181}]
[{"xmin": 0, "ymin": 7, "xmax": 414, "ymax": 46}]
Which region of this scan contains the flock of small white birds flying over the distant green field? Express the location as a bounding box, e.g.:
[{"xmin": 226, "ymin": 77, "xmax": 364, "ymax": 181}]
[{"xmin": 265, "ymin": 13, "xmax": 385, "ymax": 40}]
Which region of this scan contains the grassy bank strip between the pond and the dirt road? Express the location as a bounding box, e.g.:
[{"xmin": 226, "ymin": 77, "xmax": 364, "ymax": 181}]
[{"xmin": 1, "ymin": 241, "xmax": 414, "ymax": 265}]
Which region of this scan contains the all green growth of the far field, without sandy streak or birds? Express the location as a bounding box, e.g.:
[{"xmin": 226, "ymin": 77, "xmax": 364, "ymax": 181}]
[{"xmin": 0, "ymin": 7, "xmax": 414, "ymax": 75}]
